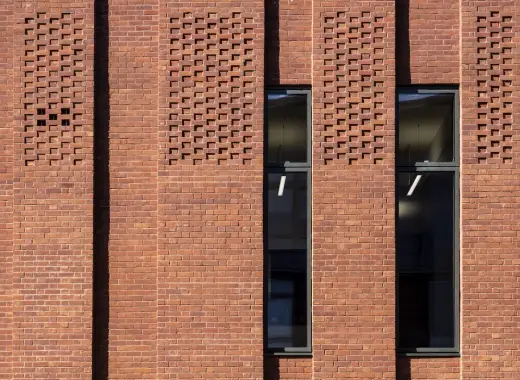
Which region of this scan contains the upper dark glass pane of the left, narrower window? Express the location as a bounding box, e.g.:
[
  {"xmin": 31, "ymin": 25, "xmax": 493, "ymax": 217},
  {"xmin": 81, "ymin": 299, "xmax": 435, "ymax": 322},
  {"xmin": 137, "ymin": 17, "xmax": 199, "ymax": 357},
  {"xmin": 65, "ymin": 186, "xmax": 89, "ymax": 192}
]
[{"xmin": 267, "ymin": 92, "xmax": 308, "ymax": 164}]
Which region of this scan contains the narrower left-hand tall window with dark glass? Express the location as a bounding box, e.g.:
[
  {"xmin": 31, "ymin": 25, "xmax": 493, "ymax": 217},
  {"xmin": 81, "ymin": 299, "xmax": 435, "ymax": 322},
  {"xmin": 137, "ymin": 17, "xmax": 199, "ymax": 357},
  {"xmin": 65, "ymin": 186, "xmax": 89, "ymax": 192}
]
[{"xmin": 264, "ymin": 89, "xmax": 311, "ymax": 353}]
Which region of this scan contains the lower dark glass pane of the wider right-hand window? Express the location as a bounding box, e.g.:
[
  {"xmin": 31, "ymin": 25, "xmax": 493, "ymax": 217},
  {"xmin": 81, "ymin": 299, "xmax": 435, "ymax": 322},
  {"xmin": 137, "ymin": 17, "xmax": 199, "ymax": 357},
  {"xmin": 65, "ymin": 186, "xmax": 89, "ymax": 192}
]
[{"xmin": 397, "ymin": 172, "xmax": 455, "ymax": 348}]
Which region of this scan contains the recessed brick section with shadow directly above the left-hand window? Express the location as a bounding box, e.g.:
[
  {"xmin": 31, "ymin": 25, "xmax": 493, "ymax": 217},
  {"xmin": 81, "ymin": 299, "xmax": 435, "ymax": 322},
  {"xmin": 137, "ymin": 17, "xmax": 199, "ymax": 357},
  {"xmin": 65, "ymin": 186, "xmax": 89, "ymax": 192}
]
[{"xmin": 265, "ymin": 0, "xmax": 312, "ymax": 85}]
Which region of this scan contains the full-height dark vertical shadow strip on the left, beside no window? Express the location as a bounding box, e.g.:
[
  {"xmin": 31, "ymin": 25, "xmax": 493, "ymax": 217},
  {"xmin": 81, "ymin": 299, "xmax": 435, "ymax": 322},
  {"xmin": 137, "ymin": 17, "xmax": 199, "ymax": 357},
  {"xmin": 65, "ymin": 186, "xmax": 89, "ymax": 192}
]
[{"xmin": 92, "ymin": 0, "xmax": 110, "ymax": 380}]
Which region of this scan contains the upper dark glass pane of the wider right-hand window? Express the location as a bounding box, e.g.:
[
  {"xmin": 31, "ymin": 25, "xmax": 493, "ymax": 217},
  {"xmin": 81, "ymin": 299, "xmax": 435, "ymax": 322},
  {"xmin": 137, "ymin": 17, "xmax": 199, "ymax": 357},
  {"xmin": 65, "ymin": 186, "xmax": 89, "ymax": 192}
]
[{"xmin": 397, "ymin": 93, "xmax": 455, "ymax": 165}]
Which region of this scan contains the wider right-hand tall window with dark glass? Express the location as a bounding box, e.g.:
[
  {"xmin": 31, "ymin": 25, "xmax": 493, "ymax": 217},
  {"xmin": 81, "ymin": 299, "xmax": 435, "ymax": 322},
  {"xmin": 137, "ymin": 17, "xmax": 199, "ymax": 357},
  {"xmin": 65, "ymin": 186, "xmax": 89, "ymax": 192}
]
[{"xmin": 396, "ymin": 89, "xmax": 459, "ymax": 354}]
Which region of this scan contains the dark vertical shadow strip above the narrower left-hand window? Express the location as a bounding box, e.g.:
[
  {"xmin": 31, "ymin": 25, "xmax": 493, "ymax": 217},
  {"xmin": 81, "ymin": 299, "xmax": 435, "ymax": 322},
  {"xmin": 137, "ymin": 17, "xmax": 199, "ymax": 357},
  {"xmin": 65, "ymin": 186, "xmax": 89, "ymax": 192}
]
[{"xmin": 265, "ymin": 0, "xmax": 280, "ymax": 85}]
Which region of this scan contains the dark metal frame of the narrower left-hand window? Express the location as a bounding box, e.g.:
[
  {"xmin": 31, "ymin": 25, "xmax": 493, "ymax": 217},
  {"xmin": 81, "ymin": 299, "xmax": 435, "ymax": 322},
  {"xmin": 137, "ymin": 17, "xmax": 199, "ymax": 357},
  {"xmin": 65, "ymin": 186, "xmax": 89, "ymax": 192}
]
[{"xmin": 263, "ymin": 86, "xmax": 312, "ymax": 356}]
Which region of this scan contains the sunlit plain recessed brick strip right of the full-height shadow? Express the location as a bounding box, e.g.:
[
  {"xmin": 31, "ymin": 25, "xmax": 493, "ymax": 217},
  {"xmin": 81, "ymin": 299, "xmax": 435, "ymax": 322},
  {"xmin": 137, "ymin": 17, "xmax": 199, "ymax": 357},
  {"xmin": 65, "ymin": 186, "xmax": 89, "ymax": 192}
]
[{"xmin": 107, "ymin": 0, "xmax": 159, "ymax": 380}]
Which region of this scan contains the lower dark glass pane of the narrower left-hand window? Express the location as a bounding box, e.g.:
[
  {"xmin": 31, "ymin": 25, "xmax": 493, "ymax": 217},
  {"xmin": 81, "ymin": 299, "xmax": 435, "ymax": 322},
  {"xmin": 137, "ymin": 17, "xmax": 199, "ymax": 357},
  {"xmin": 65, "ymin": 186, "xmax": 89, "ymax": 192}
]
[{"xmin": 267, "ymin": 173, "xmax": 307, "ymax": 348}]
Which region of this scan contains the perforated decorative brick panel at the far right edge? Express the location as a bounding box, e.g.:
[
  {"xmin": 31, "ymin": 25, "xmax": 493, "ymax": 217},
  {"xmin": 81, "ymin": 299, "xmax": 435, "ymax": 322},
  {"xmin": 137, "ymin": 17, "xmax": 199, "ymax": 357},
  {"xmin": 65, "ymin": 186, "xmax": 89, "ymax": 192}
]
[{"xmin": 475, "ymin": 10, "xmax": 515, "ymax": 163}]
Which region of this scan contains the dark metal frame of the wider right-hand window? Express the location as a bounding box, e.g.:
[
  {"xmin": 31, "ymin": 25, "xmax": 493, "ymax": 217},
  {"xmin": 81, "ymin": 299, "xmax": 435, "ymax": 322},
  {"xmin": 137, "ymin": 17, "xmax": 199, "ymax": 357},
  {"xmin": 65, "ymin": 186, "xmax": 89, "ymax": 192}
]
[{"xmin": 395, "ymin": 86, "xmax": 461, "ymax": 357}]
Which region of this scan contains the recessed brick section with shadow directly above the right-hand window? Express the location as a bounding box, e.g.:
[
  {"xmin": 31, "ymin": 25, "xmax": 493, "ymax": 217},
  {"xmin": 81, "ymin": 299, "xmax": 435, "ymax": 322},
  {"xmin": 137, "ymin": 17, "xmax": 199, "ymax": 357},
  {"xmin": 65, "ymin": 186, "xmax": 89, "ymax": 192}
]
[{"xmin": 396, "ymin": 0, "xmax": 460, "ymax": 85}]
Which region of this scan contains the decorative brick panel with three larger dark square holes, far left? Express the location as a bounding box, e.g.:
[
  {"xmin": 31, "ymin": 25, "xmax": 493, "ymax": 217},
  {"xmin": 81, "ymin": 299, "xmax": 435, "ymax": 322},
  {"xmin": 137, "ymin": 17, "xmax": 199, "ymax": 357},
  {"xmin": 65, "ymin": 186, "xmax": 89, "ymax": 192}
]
[{"xmin": 22, "ymin": 12, "xmax": 85, "ymax": 165}]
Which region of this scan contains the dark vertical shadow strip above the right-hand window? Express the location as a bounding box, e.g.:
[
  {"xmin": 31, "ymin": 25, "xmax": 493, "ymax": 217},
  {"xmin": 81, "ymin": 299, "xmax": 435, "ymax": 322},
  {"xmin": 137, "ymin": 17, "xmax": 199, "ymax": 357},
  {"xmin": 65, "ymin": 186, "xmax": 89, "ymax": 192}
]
[{"xmin": 395, "ymin": 0, "xmax": 412, "ymax": 85}]
